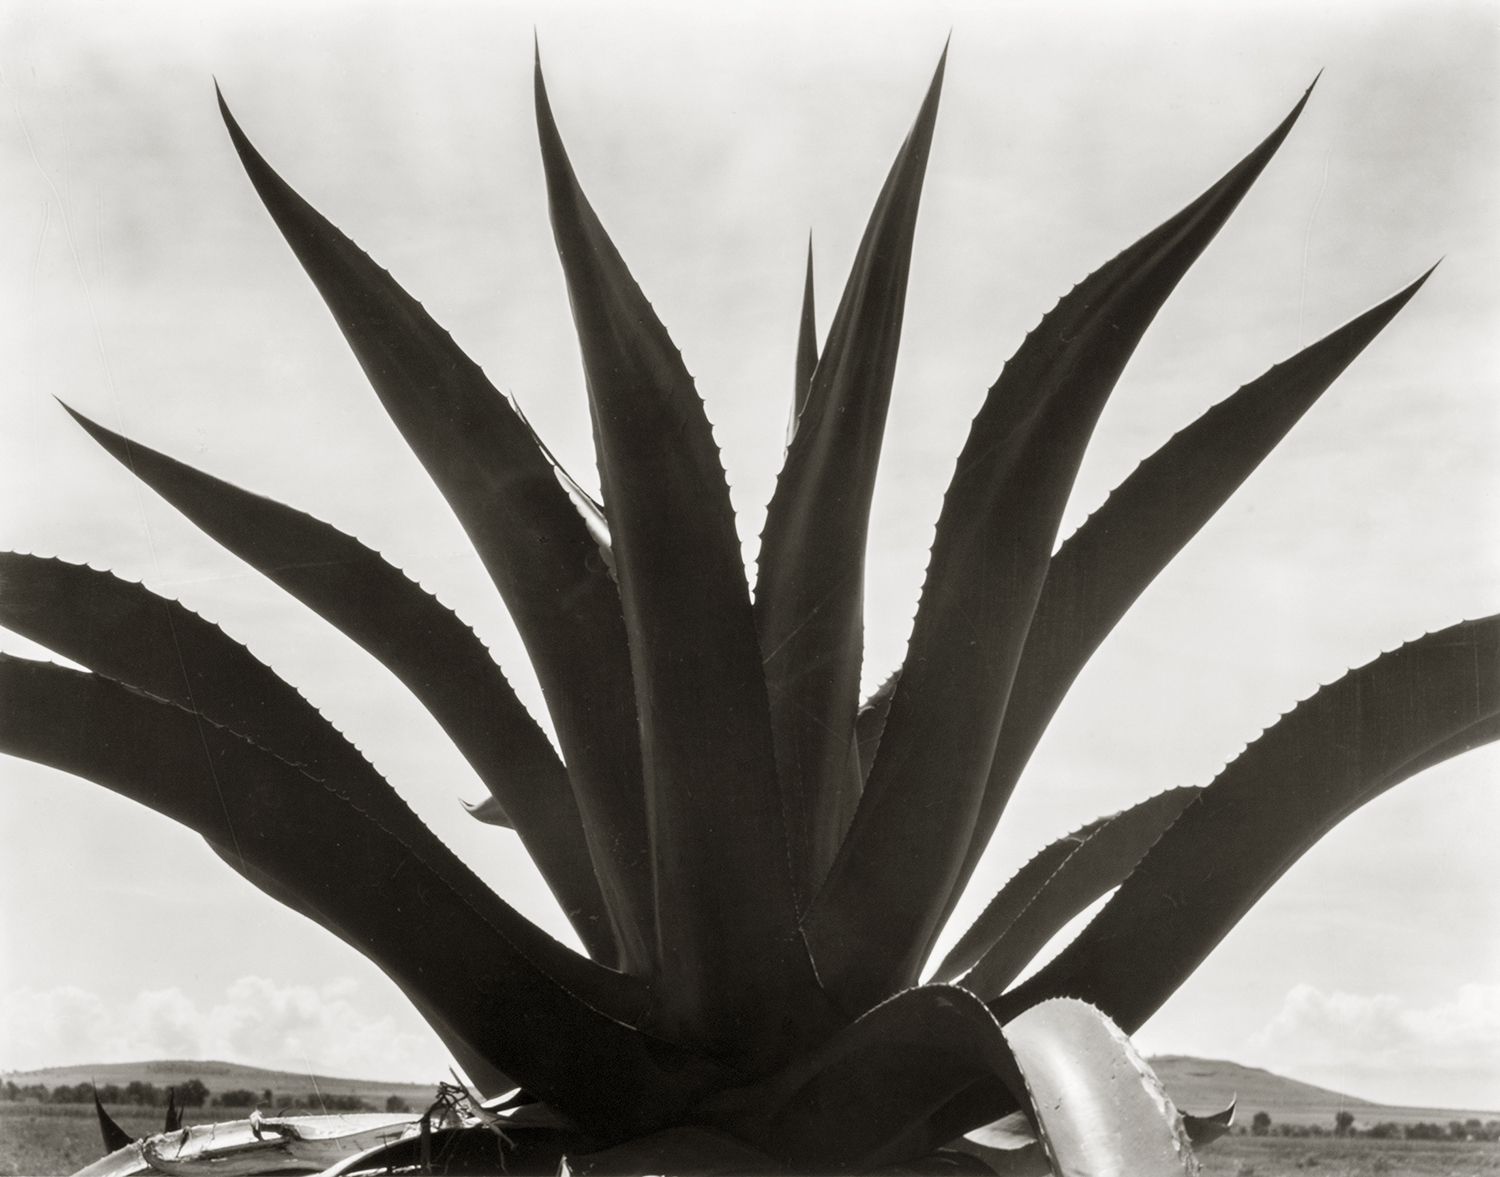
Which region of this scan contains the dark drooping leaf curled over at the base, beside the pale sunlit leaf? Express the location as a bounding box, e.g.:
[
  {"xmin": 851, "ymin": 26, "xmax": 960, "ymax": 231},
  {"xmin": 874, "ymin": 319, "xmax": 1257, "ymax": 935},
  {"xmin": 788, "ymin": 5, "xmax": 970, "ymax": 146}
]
[{"xmin": 698, "ymin": 985, "xmax": 1025, "ymax": 1173}]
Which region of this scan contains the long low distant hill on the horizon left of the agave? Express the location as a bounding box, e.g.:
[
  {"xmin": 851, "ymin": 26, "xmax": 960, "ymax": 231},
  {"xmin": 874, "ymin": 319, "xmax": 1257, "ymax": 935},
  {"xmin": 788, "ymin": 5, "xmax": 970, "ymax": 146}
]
[{"xmin": 0, "ymin": 1059, "xmax": 438, "ymax": 1108}]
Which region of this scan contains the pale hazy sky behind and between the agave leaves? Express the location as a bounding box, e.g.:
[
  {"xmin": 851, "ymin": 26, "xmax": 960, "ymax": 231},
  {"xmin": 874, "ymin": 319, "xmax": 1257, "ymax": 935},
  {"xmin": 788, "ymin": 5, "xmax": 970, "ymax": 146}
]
[{"xmin": 0, "ymin": 0, "xmax": 1500, "ymax": 1110}]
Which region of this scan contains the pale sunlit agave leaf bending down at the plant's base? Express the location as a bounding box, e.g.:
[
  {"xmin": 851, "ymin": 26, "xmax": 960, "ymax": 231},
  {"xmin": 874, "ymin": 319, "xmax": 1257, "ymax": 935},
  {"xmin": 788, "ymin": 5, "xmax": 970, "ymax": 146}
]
[{"xmin": 1005, "ymin": 1000, "xmax": 1199, "ymax": 1177}]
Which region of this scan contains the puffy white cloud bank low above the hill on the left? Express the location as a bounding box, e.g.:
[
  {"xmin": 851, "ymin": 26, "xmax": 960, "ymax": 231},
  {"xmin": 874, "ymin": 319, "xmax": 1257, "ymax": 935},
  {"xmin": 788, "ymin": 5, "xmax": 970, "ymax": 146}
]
[{"xmin": 0, "ymin": 976, "xmax": 450, "ymax": 1080}]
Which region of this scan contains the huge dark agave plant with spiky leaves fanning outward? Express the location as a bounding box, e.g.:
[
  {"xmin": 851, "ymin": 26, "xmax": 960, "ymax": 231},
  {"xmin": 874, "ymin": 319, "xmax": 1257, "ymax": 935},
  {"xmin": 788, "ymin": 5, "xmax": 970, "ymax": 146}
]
[{"xmin": 0, "ymin": 41, "xmax": 1500, "ymax": 1173}]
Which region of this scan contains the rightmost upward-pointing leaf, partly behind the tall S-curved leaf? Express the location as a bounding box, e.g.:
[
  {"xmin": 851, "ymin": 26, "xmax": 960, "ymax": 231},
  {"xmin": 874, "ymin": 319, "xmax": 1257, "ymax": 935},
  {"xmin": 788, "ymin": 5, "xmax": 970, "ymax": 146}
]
[{"xmin": 944, "ymin": 270, "xmax": 1431, "ymax": 947}]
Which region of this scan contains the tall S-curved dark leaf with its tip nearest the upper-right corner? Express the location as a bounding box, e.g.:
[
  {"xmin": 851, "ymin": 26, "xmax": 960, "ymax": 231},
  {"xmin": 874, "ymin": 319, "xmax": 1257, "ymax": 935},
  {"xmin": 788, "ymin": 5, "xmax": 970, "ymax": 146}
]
[{"xmin": 804, "ymin": 87, "xmax": 1307, "ymax": 1009}]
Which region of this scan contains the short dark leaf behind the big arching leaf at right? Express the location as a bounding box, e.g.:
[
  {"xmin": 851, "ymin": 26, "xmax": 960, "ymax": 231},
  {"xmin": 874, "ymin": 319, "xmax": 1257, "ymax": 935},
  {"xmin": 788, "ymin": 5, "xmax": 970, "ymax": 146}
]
[{"xmin": 963, "ymin": 789, "xmax": 1203, "ymax": 1002}]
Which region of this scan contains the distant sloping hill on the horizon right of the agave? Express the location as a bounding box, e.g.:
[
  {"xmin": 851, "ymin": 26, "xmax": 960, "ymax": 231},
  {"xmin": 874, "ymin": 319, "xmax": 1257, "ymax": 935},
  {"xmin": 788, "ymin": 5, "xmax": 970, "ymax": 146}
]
[{"xmin": 1149, "ymin": 1054, "xmax": 1500, "ymax": 1128}]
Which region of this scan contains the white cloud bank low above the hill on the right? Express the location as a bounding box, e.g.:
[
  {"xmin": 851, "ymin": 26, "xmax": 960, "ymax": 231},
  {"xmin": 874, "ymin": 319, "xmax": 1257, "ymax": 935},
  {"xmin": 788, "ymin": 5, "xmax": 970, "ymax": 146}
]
[{"xmin": 1248, "ymin": 985, "xmax": 1500, "ymax": 1110}]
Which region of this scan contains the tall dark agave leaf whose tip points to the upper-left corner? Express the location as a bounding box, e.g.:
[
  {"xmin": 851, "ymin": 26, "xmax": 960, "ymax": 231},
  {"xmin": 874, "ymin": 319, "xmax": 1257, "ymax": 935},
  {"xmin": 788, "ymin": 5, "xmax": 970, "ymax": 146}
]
[{"xmin": 219, "ymin": 96, "xmax": 656, "ymax": 973}]
